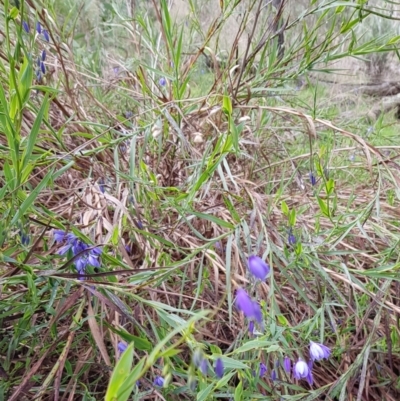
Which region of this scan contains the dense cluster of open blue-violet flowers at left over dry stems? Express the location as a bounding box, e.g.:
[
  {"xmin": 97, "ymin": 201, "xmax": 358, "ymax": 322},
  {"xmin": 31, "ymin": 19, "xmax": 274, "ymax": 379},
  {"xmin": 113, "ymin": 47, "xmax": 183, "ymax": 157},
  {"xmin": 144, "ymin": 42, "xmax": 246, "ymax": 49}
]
[{"xmin": 54, "ymin": 230, "xmax": 102, "ymax": 274}]
